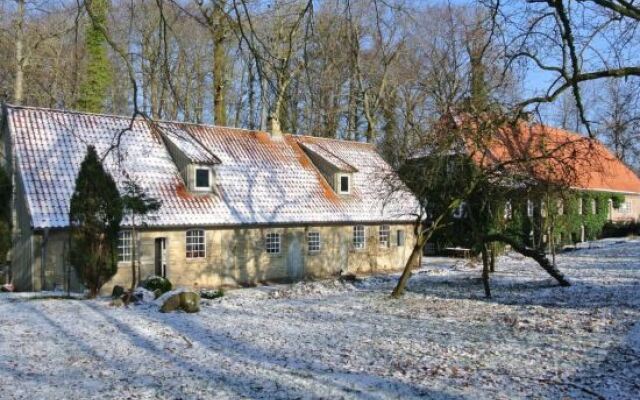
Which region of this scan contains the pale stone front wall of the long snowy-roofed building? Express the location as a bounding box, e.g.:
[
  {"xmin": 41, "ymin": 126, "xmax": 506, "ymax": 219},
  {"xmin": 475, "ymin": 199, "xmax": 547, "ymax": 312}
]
[{"xmin": 25, "ymin": 225, "xmax": 415, "ymax": 293}]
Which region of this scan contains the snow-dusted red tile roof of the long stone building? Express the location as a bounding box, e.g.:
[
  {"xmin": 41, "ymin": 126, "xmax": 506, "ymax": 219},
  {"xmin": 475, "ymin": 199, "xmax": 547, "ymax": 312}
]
[{"xmin": 6, "ymin": 106, "xmax": 417, "ymax": 228}]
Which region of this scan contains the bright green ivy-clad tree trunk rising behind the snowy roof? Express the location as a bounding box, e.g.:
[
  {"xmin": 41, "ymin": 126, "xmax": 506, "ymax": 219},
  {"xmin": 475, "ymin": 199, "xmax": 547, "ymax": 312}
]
[{"xmin": 77, "ymin": 0, "xmax": 111, "ymax": 113}]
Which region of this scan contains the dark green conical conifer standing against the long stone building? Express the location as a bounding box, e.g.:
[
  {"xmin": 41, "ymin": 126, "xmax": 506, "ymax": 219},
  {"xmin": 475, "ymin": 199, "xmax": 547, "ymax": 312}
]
[{"xmin": 69, "ymin": 146, "xmax": 123, "ymax": 297}]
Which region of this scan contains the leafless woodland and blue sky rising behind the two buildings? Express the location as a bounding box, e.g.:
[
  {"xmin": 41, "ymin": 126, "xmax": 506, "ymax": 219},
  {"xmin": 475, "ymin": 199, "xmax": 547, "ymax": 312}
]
[{"xmin": 0, "ymin": 0, "xmax": 640, "ymax": 170}]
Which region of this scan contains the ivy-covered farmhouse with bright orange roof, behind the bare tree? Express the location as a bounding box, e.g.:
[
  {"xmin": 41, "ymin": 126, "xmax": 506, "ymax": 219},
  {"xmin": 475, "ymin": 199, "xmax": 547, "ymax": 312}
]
[{"xmin": 428, "ymin": 118, "xmax": 640, "ymax": 251}]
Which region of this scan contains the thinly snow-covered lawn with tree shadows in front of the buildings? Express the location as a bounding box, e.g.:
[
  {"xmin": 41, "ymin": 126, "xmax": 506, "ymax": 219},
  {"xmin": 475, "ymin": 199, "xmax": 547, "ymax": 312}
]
[{"xmin": 0, "ymin": 240, "xmax": 640, "ymax": 399}]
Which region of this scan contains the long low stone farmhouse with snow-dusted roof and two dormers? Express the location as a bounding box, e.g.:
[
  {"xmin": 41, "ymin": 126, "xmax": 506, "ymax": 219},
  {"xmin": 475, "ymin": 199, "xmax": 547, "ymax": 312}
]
[{"xmin": 0, "ymin": 106, "xmax": 417, "ymax": 290}]
